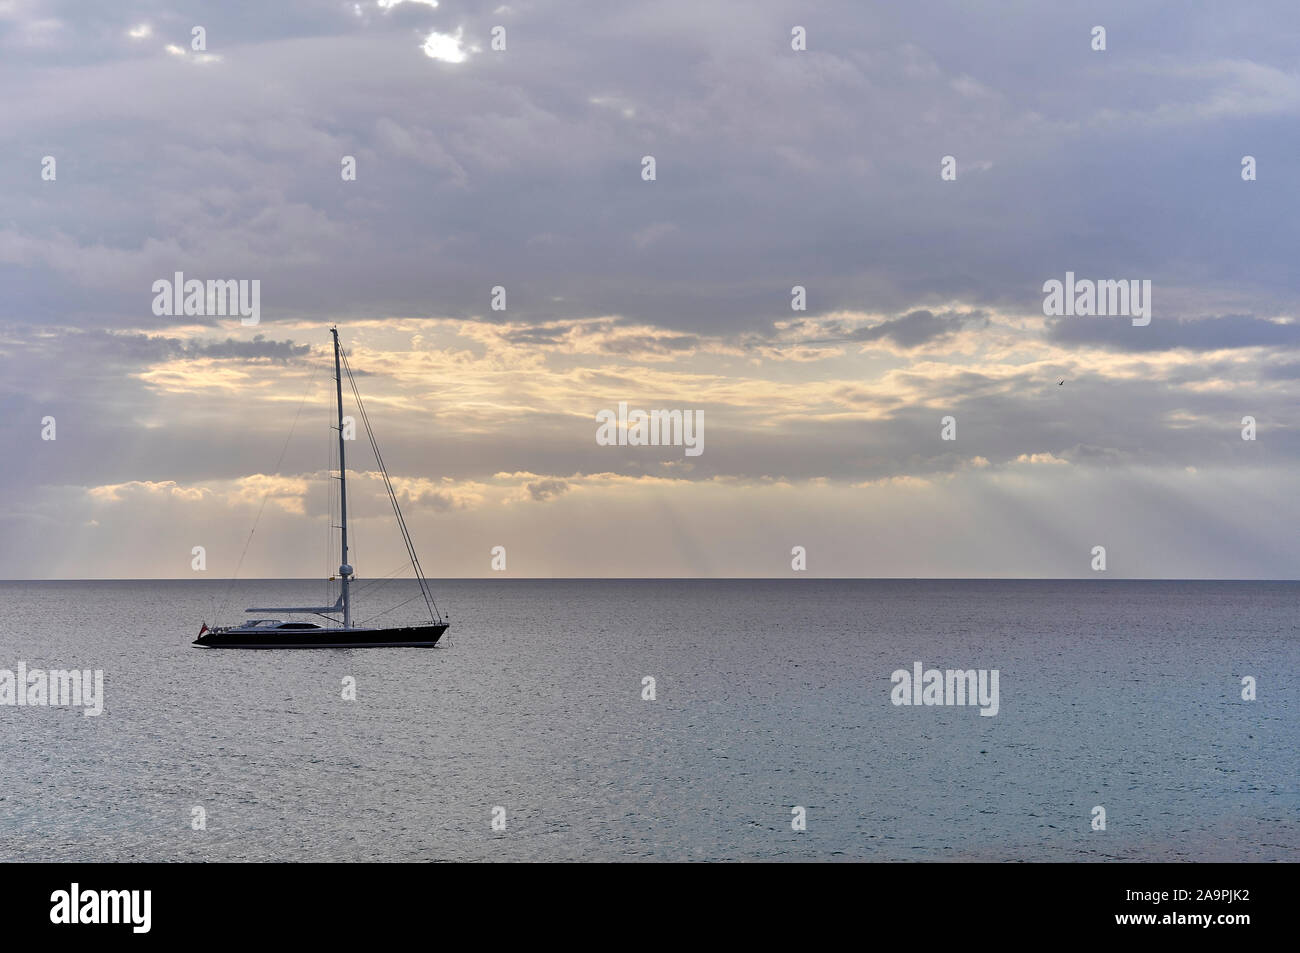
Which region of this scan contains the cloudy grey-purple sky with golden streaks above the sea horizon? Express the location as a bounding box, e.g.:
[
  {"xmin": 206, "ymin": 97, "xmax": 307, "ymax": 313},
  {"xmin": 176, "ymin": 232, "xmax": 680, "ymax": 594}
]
[{"xmin": 0, "ymin": 0, "xmax": 1300, "ymax": 579}]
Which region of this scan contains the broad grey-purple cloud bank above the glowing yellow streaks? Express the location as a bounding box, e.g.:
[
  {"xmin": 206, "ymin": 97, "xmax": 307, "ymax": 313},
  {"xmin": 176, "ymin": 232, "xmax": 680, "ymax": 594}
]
[{"xmin": 0, "ymin": 1, "xmax": 1300, "ymax": 330}]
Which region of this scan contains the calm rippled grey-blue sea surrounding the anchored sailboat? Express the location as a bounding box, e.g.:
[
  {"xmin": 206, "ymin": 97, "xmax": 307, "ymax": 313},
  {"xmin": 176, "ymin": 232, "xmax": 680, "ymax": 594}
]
[{"xmin": 0, "ymin": 579, "xmax": 1300, "ymax": 862}]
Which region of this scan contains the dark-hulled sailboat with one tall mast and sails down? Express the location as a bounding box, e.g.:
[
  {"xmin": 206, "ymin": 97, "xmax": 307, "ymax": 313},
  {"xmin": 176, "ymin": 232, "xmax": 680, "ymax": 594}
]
[{"xmin": 194, "ymin": 328, "xmax": 450, "ymax": 649}]
